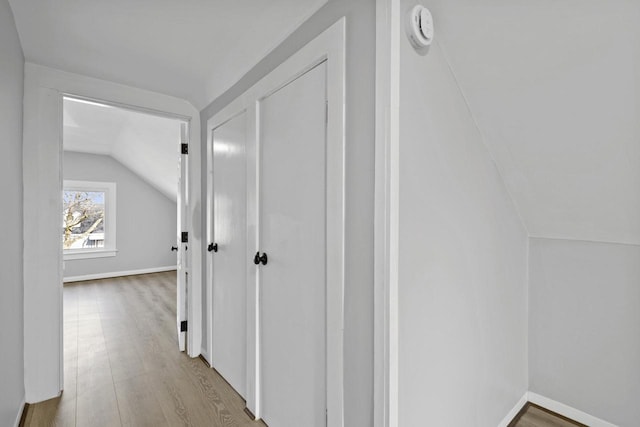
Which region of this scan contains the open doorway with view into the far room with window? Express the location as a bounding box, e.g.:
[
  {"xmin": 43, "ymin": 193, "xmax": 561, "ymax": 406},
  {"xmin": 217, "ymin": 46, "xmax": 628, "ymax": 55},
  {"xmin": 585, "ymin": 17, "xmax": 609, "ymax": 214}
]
[{"xmin": 58, "ymin": 95, "xmax": 188, "ymax": 425}]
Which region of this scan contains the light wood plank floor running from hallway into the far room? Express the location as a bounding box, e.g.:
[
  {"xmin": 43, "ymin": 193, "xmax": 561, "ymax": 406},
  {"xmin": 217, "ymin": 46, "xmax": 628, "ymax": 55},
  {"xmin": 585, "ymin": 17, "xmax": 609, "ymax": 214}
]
[{"xmin": 24, "ymin": 272, "xmax": 265, "ymax": 427}]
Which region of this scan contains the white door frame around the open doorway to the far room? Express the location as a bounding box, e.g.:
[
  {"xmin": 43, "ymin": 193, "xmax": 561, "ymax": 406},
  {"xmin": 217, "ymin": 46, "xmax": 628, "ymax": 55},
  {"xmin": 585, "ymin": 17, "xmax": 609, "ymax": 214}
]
[{"xmin": 23, "ymin": 63, "xmax": 203, "ymax": 403}]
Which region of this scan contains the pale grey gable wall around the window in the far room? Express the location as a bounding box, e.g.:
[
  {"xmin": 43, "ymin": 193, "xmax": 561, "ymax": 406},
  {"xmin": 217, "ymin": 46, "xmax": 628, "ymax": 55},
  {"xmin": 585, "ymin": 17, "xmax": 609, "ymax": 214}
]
[{"xmin": 63, "ymin": 152, "xmax": 178, "ymax": 278}]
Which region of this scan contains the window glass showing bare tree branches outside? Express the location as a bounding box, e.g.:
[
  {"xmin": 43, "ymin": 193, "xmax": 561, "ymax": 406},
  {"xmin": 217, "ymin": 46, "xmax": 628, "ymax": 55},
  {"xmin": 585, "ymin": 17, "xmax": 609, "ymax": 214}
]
[{"xmin": 62, "ymin": 190, "xmax": 105, "ymax": 249}]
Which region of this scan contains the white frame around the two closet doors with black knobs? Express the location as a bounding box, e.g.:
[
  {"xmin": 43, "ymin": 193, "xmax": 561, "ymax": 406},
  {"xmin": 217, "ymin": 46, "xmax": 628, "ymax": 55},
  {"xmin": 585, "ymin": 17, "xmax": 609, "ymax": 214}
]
[{"xmin": 206, "ymin": 17, "xmax": 346, "ymax": 427}]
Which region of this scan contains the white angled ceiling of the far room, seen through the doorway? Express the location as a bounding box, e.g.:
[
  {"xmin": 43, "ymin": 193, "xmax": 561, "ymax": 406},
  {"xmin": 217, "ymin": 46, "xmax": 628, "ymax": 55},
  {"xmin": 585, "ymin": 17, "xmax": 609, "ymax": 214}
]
[{"xmin": 63, "ymin": 99, "xmax": 180, "ymax": 201}]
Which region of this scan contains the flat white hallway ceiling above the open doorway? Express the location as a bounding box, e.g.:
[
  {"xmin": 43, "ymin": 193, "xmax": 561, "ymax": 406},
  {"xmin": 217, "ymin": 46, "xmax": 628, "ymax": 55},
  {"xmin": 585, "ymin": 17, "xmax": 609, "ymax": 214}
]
[{"xmin": 9, "ymin": 0, "xmax": 327, "ymax": 109}]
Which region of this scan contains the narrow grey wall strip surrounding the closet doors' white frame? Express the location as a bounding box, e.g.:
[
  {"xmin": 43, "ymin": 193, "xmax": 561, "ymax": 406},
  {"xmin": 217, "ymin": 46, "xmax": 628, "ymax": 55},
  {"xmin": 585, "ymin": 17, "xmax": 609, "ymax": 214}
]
[{"xmin": 200, "ymin": 0, "xmax": 375, "ymax": 427}]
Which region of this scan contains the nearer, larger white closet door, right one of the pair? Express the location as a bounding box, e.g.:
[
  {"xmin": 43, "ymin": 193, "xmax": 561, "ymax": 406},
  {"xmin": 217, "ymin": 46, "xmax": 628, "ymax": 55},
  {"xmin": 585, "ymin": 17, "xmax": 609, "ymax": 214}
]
[{"xmin": 259, "ymin": 63, "xmax": 327, "ymax": 427}]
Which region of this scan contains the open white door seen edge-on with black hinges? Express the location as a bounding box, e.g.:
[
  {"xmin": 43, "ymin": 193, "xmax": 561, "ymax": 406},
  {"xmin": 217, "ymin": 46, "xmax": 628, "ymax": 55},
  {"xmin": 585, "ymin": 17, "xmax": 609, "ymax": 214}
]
[{"xmin": 176, "ymin": 123, "xmax": 189, "ymax": 351}]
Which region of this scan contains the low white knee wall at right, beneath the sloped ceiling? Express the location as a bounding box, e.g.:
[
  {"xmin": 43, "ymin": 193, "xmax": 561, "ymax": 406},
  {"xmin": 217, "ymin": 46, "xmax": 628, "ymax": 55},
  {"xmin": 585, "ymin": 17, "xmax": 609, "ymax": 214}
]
[{"xmin": 529, "ymin": 238, "xmax": 640, "ymax": 427}]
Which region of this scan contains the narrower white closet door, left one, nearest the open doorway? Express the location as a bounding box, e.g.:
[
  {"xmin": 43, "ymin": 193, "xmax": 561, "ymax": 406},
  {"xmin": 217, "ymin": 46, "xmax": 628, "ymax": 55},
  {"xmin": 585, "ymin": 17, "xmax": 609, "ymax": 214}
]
[{"xmin": 208, "ymin": 112, "xmax": 248, "ymax": 396}]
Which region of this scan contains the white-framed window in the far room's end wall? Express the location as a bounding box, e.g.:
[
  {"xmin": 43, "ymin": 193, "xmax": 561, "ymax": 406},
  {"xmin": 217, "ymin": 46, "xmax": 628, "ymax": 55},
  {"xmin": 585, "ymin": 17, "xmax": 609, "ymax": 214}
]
[{"xmin": 62, "ymin": 180, "xmax": 117, "ymax": 260}]
